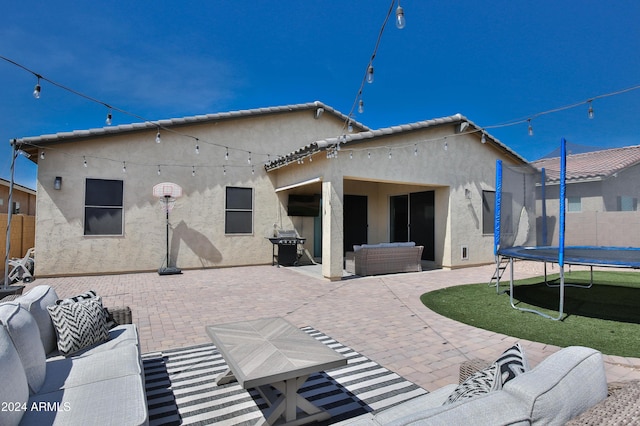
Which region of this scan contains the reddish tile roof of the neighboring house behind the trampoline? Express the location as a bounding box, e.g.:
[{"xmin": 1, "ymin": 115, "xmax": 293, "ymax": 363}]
[{"xmin": 531, "ymin": 145, "xmax": 640, "ymax": 182}]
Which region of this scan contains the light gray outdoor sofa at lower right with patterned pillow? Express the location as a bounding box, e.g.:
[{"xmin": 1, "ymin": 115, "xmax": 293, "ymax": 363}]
[{"xmin": 339, "ymin": 345, "xmax": 608, "ymax": 426}]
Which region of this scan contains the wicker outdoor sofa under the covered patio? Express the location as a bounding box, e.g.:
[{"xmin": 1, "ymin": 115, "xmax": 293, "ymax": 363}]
[{"xmin": 345, "ymin": 242, "xmax": 424, "ymax": 277}]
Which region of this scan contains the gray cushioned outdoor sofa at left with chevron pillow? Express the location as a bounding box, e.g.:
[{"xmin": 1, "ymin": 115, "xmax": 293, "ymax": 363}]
[{"xmin": 0, "ymin": 285, "xmax": 148, "ymax": 426}]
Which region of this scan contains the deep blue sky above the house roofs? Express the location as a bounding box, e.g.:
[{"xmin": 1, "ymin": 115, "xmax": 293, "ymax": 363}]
[{"xmin": 0, "ymin": 0, "xmax": 640, "ymax": 187}]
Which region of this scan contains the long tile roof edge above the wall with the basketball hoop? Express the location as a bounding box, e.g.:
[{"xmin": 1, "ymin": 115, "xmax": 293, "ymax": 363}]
[{"xmin": 16, "ymin": 101, "xmax": 369, "ymax": 145}]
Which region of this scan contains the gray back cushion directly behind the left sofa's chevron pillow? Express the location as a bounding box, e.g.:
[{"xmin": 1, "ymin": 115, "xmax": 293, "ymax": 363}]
[{"xmin": 16, "ymin": 285, "xmax": 58, "ymax": 354}]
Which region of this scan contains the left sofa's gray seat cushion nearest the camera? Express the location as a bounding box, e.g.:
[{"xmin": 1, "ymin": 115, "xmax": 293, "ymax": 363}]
[{"xmin": 20, "ymin": 375, "xmax": 148, "ymax": 426}]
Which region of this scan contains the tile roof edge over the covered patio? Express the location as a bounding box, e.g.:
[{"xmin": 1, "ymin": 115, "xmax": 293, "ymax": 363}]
[{"xmin": 265, "ymin": 114, "xmax": 527, "ymax": 171}]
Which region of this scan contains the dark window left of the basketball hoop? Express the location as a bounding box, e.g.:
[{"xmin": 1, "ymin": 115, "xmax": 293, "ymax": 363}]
[{"xmin": 84, "ymin": 179, "xmax": 123, "ymax": 235}]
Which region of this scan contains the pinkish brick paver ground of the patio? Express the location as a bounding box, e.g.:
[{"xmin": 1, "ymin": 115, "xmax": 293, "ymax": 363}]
[{"xmin": 16, "ymin": 262, "xmax": 640, "ymax": 391}]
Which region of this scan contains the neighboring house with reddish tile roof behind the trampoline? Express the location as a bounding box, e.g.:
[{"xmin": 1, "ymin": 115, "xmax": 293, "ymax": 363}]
[{"xmin": 532, "ymin": 146, "xmax": 640, "ymax": 247}]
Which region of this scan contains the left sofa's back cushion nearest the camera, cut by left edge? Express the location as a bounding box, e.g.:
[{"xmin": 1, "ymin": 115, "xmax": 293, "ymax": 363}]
[{"xmin": 0, "ymin": 327, "xmax": 29, "ymax": 426}]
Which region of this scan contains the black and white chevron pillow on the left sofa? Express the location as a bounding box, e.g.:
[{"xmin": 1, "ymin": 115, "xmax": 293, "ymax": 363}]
[{"xmin": 47, "ymin": 297, "xmax": 109, "ymax": 356}]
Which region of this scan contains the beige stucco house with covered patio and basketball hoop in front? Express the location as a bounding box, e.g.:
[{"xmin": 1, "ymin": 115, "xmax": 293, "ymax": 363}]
[{"xmin": 16, "ymin": 102, "xmax": 526, "ymax": 279}]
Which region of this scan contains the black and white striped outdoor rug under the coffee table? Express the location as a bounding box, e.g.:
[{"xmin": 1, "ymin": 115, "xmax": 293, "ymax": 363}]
[{"xmin": 142, "ymin": 327, "xmax": 427, "ymax": 425}]
